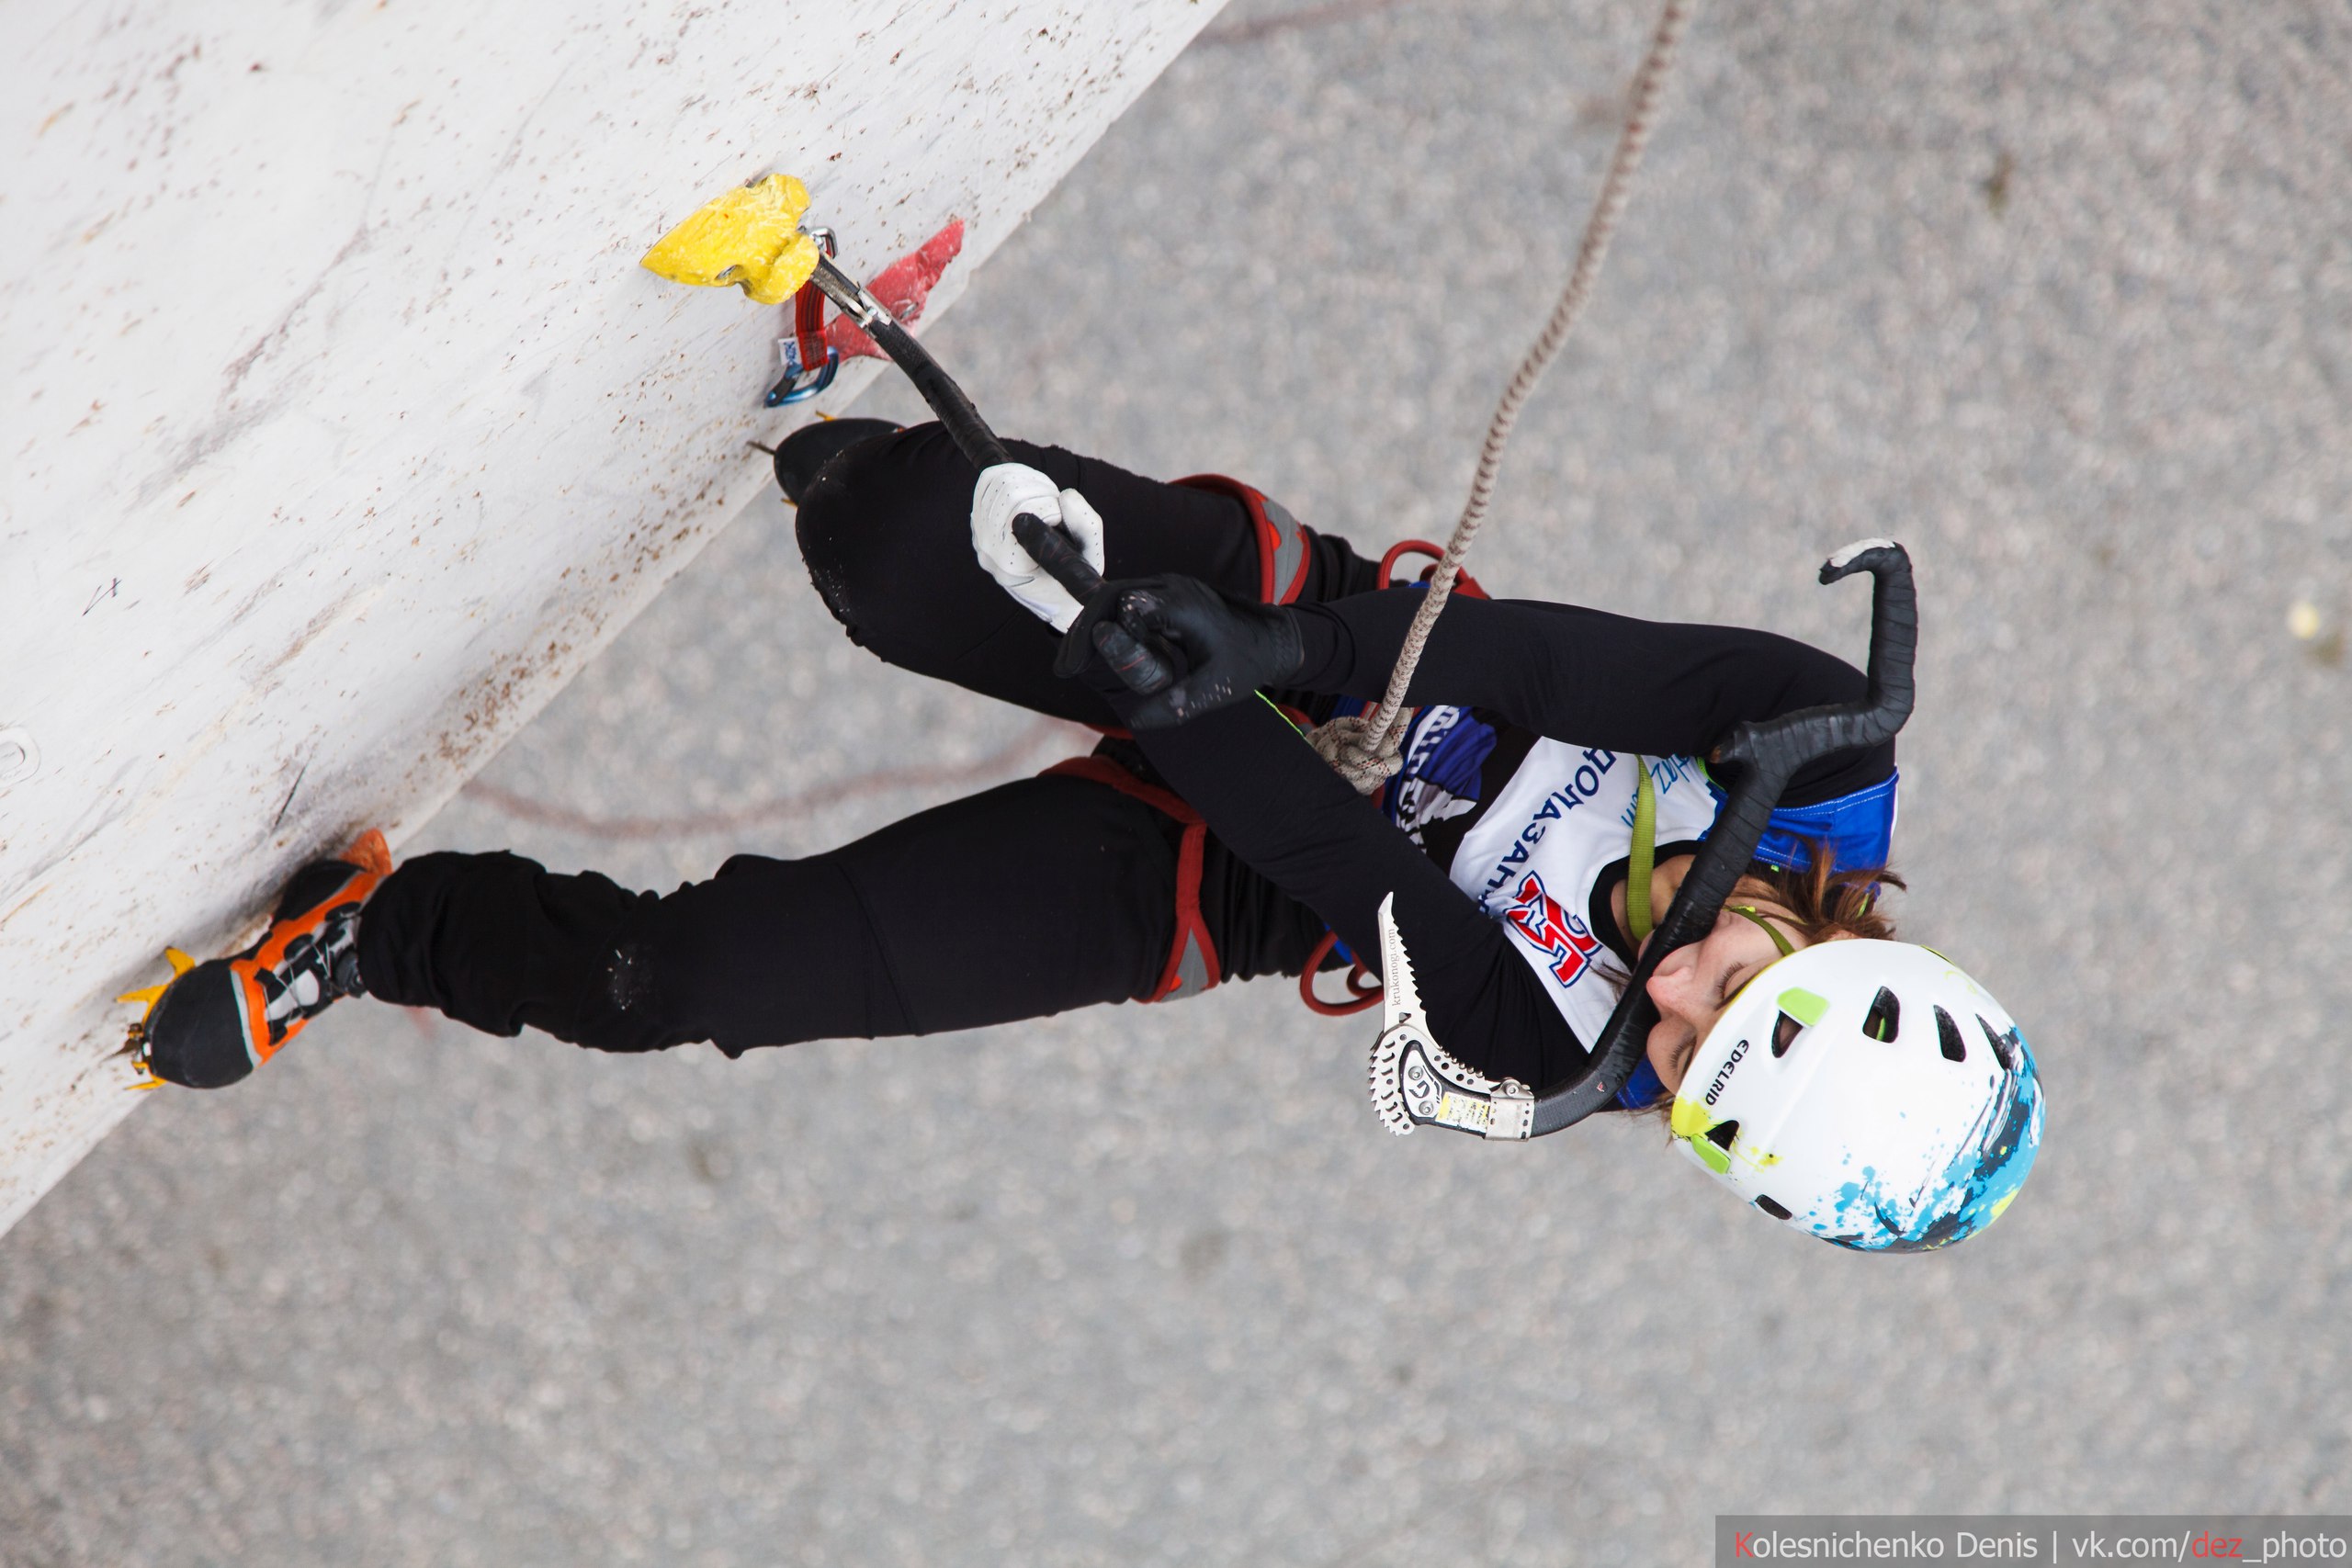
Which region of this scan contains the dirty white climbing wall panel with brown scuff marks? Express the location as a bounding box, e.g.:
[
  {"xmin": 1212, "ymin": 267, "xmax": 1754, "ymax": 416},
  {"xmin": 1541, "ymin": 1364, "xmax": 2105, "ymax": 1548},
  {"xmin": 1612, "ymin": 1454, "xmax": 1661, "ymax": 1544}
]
[{"xmin": 0, "ymin": 0, "xmax": 1221, "ymax": 1229}]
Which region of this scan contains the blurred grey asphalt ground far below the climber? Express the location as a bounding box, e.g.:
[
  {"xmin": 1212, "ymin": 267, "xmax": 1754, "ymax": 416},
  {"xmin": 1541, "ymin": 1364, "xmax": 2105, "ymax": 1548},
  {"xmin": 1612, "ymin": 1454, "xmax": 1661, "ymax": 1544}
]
[{"xmin": 0, "ymin": 0, "xmax": 2352, "ymax": 1565}]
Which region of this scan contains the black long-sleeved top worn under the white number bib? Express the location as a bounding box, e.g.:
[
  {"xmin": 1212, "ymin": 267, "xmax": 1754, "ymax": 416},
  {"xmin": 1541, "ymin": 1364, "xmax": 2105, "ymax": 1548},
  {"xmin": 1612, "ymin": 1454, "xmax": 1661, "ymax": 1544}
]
[{"xmin": 1119, "ymin": 588, "xmax": 1894, "ymax": 1086}]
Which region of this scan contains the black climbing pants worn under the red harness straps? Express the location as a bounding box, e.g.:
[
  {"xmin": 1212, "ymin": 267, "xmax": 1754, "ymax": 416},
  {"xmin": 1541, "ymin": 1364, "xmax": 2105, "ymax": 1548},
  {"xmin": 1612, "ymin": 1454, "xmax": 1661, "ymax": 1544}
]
[{"xmin": 360, "ymin": 425, "xmax": 1374, "ymax": 1055}]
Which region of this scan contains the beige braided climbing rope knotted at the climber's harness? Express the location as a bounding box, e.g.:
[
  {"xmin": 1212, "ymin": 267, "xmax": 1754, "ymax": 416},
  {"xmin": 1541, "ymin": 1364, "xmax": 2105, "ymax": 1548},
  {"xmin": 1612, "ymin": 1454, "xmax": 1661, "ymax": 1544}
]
[{"xmin": 1307, "ymin": 0, "xmax": 1689, "ymax": 795}]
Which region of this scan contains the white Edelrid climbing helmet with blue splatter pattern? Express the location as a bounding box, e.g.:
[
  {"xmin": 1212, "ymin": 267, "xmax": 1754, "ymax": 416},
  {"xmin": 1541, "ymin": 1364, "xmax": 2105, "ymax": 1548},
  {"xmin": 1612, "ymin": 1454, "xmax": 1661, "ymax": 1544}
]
[{"xmin": 1672, "ymin": 941, "xmax": 2041, "ymax": 1253}]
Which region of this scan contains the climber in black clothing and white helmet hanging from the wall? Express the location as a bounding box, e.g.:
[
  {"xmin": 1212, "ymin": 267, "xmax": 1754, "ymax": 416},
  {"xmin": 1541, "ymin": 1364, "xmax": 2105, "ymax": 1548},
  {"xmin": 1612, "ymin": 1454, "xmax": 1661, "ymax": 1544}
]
[{"xmin": 134, "ymin": 421, "xmax": 2041, "ymax": 1251}]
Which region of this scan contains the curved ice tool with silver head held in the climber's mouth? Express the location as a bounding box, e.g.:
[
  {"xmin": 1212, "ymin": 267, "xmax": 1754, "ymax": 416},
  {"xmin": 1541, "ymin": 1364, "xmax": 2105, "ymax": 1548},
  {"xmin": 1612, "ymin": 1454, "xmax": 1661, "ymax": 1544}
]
[{"xmin": 1371, "ymin": 538, "xmax": 1919, "ymax": 1138}]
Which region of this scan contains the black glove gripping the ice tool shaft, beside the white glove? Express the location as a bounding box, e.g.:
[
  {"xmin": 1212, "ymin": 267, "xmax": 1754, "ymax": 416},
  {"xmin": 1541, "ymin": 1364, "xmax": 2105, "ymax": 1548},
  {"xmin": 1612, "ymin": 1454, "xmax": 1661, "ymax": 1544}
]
[{"xmin": 1054, "ymin": 573, "xmax": 1306, "ymax": 728}]
